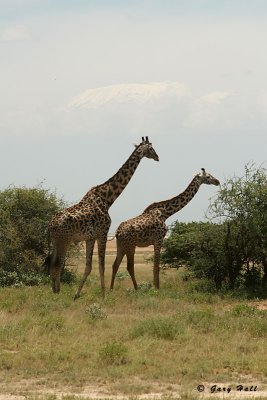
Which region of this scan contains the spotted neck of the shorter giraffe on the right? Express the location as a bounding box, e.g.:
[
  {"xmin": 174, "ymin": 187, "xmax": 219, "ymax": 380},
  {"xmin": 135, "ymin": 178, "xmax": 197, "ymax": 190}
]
[{"xmin": 144, "ymin": 176, "xmax": 201, "ymax": 219}]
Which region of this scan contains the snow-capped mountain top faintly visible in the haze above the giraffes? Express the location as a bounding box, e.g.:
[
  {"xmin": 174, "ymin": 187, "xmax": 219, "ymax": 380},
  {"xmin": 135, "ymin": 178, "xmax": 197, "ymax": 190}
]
[{"xmin": 69, "ymin": 82, "xmax": 189, "ymax": 109}]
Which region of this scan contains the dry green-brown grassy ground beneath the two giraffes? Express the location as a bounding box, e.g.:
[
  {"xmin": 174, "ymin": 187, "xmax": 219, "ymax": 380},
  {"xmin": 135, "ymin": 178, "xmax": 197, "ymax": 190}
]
[{"xmin": 0, "ymin": 241, "xmax": 267, "ymax": 400}]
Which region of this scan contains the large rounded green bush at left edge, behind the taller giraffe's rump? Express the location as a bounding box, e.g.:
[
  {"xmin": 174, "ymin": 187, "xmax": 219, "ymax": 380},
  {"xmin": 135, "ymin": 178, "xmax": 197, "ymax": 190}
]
[{"xmin": 0, "ymin": 186, "xmax": 70, "ymax": 286}]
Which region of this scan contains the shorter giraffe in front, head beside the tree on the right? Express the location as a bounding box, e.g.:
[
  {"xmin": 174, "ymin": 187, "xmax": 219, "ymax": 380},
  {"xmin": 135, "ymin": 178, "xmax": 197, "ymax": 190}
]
[{"xmin": 110, "ymin": 168, "xmax": 220, "ymax": 290}]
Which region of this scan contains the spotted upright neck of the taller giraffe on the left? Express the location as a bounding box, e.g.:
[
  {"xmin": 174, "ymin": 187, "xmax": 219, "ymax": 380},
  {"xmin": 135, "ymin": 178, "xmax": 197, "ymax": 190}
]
[{"xmin": 81, "ymin": 147, "xmax": 142, "ymax": 208}]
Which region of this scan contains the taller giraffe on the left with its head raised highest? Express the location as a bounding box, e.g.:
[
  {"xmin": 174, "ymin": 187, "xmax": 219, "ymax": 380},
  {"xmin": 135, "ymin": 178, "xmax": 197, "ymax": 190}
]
[{"xmin": 43, "ymin": 136, "xmax": 159, "ymax": 299}]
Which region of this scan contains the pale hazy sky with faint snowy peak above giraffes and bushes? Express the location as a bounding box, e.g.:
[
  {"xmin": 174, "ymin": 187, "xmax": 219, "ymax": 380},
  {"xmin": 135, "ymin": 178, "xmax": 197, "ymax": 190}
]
[{"xmin": 0, "ymin": 0, "xmax": 267, "ymax": 233}]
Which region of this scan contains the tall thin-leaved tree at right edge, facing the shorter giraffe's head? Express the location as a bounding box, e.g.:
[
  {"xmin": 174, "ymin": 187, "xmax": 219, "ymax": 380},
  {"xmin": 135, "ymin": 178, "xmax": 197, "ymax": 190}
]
[{"xmin": 208, "ymin": 164, "xmax": 267, "ymax": 286}]
